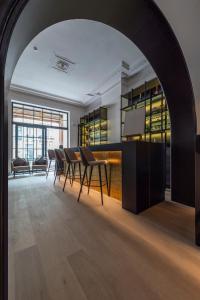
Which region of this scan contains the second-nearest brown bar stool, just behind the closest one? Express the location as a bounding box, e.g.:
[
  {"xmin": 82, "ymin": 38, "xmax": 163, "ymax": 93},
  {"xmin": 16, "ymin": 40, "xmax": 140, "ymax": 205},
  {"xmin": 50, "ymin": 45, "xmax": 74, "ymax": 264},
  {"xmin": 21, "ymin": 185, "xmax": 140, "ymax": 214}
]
[{"xmin": 63, "ymin": 148, "xmax": 81, "ymax": 192}]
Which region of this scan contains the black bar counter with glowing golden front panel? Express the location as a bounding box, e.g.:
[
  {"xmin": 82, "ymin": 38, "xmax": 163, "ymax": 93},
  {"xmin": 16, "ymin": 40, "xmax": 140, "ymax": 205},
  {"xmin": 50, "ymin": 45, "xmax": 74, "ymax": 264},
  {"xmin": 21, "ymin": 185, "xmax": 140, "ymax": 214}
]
[{"xmin": 74, "ymin": 141, "xmax": 164, "ymax": 214}]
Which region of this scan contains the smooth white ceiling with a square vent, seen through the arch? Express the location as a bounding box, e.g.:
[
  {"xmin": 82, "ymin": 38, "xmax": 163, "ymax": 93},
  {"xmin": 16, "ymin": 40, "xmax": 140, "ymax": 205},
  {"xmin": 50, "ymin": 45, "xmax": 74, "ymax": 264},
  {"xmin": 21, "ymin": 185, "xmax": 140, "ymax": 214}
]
[{"xmin": 12, "ymin": 20, "xmax": 145, "ymax": 104}]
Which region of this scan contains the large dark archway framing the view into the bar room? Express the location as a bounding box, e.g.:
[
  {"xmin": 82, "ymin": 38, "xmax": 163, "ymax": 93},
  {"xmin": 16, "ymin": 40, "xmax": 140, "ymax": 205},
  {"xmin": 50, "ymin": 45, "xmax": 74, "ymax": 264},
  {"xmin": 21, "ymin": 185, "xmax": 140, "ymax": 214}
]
[{"xmin": 0, "ymin": 0, "xmax": 200, "ymax": 297}]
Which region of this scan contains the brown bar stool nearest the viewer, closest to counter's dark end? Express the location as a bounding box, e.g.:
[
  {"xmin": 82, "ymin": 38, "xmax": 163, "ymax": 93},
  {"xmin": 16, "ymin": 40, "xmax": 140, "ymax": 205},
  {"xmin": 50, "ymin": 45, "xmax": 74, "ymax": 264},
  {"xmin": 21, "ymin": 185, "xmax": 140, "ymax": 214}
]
[{"xmin": 77, "ymin": 147, "xmax": 109, "ymax": 205}]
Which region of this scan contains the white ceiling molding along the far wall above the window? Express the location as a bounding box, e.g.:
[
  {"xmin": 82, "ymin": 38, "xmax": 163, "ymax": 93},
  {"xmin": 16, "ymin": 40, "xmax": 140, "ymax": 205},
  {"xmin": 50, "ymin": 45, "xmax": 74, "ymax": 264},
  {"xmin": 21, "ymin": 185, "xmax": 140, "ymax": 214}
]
[{"xmin": 10, "ymin": 84, "xmax": 85, "ymax": 107}]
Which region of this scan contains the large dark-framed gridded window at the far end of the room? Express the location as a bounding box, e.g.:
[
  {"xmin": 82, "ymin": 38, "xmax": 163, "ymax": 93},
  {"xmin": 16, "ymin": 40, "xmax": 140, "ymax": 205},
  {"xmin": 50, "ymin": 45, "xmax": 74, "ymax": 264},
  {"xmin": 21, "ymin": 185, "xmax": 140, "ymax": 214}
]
[{"xmin": 12, "ymin": 102, "xmax": 69, "ymax": 161}]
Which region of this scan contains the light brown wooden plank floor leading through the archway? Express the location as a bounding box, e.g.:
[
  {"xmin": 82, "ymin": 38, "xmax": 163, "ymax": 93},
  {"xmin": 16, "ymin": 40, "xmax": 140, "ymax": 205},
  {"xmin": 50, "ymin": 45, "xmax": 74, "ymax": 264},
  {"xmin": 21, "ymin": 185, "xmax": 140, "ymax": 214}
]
[{"xmin": 9, "ymin": 176, "xmax": 200, "ymax": 300}]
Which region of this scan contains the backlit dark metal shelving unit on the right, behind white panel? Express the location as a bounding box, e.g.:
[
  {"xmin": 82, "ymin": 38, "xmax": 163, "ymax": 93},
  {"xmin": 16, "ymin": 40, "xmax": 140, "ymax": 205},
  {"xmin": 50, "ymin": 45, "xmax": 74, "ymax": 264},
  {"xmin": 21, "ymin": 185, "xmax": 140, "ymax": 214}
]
[{"xmin": 121, "ymin": 78, "xmax": 171, "ymax": 145}]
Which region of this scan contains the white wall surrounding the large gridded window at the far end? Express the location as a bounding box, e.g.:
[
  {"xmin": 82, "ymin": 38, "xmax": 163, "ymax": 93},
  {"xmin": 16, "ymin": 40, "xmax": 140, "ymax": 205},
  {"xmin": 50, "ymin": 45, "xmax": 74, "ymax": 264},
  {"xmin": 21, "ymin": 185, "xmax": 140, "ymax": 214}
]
[{"xmin": 8, "ymin": 90, "xmax": 85, "ymax": 170}]
